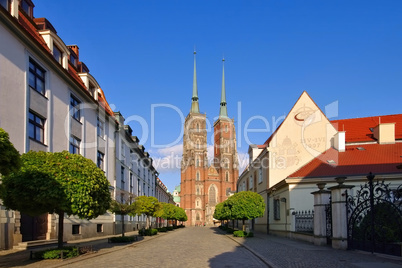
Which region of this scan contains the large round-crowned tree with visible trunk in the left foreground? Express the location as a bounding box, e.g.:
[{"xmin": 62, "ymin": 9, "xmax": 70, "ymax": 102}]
[{"xmin": 0, "ymin": 151, "xmax": 111, "ymax": 248}]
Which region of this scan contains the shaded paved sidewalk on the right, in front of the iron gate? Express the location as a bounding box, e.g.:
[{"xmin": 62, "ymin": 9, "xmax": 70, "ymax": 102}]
[{"xmin": 226, "ymin": 230, "xmax": 402, "ymax": 268}]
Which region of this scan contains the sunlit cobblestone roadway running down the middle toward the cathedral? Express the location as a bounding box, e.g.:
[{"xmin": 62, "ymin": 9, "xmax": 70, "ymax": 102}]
[{"xmin": 55, "ymin": 227, "xmax": 266, "ymax": 267}]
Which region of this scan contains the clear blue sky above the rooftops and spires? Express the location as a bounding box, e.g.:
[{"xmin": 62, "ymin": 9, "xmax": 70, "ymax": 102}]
[{"xmin": 34, "ymin": 0, "xmax": 402, "ymax": 191}]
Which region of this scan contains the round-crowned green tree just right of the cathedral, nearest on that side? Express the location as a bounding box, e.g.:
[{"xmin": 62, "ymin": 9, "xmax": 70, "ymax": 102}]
[{"xmin": 227, "ymin": 191, "xmax": 265, "ymax": 231}]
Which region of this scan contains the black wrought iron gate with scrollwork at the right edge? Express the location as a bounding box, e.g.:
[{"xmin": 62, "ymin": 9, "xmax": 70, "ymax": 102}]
[{"xmin": 345, "ymin": 173, "xmax": 402, "ymax": 256}]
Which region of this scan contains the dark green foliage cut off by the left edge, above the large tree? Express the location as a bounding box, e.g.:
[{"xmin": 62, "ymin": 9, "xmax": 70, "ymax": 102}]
[{"xmin": 0, "ymin": 128, "xmax": 21, "ymax": 176}]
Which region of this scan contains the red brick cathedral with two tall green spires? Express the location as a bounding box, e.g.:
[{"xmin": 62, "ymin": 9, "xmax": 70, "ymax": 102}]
[{"xmin": 180, "ymin": 52, "xmax": 239, "ymax": 226}]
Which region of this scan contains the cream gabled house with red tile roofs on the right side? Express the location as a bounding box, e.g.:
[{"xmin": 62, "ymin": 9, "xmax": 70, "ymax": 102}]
[{"xmin": 238, "ymin": 92, "xmax": 402, "ymax": 241}]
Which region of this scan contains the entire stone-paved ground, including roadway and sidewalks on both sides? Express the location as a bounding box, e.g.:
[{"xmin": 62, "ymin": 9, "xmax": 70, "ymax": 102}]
[{"xmin": 0, "ymin": 227, "xmax": 402, "ymax": 268}]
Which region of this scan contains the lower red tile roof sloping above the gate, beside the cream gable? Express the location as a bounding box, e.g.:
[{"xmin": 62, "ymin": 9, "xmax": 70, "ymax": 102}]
[{"xmin": 288, "ymin": 143, "xmax": 402, "ymax": 178}]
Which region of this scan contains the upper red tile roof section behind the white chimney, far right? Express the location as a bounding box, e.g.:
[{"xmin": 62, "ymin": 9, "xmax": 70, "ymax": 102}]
[{"xmin": 331, "ymin": 114, "xmax": 402, "ymax": 143}]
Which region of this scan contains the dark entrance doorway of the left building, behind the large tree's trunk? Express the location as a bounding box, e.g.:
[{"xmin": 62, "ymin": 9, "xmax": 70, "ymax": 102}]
[{"xmin": 21, "ymin": 213, "xmax": 48, "ymax": 242}]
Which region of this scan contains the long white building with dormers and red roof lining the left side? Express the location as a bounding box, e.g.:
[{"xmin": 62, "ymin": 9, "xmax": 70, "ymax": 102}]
[{"xmin": 0, "ymin": 0, "xmax": 157, "ymax": 249}]
